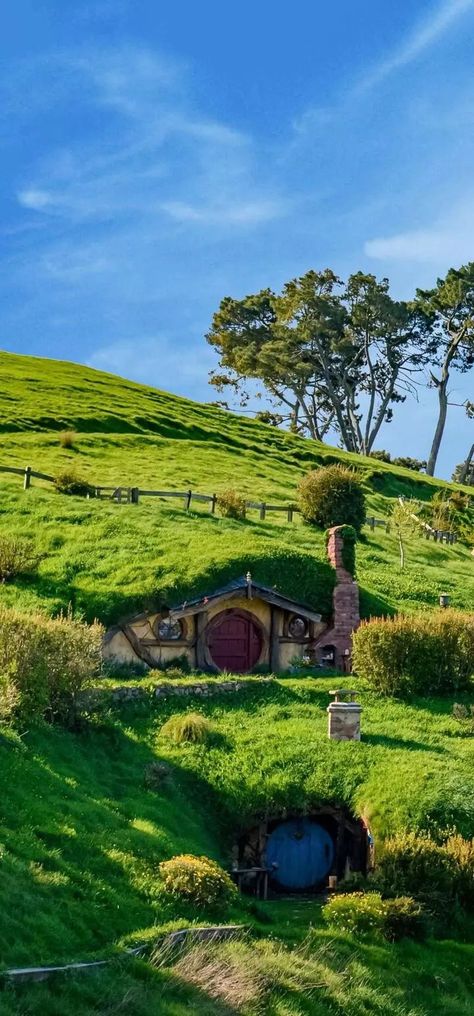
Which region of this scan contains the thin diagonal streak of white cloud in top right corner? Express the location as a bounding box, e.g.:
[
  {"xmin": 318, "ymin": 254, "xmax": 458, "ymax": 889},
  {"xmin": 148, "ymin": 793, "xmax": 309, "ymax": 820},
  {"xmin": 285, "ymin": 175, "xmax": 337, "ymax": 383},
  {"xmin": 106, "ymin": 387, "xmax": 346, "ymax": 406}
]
[{"xmin": 355, "ymin": 0, "xmax": 474, "ymax": 93}]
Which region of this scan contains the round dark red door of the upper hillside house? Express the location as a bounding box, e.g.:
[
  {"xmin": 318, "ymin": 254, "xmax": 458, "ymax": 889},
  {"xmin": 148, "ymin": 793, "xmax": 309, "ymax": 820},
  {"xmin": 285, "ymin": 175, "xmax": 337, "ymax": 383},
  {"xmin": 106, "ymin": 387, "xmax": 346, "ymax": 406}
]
[{"xmin": 207, "ymin": 611, "xmax": 262, "ymax": 674}]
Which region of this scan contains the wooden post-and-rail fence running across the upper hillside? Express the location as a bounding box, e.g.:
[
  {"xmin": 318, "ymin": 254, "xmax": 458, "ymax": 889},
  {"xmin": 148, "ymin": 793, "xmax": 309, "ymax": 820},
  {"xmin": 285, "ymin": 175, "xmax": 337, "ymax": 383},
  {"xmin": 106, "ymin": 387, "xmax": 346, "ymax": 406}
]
[{"xmin": 0, "ymin": 465, "xmax": 458, "ymax": 544}]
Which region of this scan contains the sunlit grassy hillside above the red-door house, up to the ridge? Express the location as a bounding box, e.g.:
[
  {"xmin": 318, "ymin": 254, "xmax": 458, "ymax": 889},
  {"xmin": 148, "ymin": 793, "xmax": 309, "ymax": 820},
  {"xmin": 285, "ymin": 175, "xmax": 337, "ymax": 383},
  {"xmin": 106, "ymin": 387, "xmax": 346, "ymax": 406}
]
[{"xmin": 0, "ymin": 354, "xmax": 474, "ymax": 624}]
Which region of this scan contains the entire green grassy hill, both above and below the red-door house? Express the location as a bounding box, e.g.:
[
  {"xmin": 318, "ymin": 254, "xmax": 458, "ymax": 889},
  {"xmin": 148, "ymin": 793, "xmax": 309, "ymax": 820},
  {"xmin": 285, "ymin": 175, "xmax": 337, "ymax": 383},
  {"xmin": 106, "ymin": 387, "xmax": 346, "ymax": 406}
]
[{"xmin": 0, "ymin": 354, "xmax": 474, "ymax": 1016}]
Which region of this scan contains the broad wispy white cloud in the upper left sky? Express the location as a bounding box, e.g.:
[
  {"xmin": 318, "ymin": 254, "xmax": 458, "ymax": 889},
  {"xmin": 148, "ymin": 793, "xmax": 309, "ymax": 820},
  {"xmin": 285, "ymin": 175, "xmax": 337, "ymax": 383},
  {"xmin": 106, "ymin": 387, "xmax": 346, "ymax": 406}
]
[{"xmin": 16, "ymin": 48, "xmax": 285, "ymax": 229}]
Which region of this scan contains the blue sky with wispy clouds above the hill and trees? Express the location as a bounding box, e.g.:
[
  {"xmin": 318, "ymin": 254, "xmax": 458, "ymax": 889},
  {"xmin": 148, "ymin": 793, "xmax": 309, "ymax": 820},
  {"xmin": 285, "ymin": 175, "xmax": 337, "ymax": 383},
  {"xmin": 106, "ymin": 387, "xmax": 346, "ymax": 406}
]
[{"xmin": 0, "ymin": 0, "xmax": 474, "ymax": 475}]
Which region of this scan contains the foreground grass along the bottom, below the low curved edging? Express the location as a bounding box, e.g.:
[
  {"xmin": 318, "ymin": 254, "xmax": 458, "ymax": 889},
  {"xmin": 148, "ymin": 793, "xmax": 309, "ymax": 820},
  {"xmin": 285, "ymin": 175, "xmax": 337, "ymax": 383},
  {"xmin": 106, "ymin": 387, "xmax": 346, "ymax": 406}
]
[{"xmin": 1, "ymin": 925, "xmax": 474, "ymax": 1016}]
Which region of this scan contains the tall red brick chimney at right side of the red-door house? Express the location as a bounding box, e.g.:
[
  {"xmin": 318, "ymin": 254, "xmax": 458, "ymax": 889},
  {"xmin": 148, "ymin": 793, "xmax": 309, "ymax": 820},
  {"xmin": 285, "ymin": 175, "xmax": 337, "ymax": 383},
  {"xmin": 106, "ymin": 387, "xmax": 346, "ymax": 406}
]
[{"xmin": 316, "ymin": 525, "xmax": 360, "ymax": 673}]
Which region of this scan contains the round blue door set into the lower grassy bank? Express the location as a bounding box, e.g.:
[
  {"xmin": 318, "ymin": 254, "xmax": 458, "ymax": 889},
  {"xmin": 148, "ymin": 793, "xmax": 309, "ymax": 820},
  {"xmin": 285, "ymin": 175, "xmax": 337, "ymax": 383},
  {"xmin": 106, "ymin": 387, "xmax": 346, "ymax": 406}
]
[{"xmin": 267, "ymin": 819, "xmax": 334, "ymax": 889}]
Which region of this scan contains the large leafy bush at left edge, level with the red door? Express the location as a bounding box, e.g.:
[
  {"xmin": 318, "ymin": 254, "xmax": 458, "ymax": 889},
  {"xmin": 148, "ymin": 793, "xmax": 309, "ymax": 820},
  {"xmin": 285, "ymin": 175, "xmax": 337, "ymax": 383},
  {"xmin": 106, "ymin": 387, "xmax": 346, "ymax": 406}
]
[{"xmin": 0, "ymin": 607, "xmax": 103, "ymax": 721}]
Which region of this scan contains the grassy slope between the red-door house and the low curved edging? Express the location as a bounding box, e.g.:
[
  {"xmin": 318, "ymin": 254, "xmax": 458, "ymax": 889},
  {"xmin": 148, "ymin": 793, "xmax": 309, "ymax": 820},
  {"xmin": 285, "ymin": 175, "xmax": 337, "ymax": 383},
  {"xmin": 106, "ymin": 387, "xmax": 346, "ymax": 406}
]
[{"xmin": 0, "ymin": 679, "xmax": 474, "ymax": 964}]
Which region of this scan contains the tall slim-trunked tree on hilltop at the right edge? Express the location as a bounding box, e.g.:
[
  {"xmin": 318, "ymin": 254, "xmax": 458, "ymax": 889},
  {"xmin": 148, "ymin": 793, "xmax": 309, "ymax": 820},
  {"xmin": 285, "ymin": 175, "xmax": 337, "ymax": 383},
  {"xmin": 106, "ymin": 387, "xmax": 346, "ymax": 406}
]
[{"xmin": 413, "ymin": 261, "xmax": 474, "ymax": 477}]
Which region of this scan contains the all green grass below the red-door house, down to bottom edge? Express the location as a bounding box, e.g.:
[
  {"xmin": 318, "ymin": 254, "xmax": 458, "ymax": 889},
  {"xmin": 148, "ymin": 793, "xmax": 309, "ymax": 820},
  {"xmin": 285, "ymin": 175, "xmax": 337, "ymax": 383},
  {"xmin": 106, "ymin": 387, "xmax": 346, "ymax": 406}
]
[{"xmin": 0, "ymin": 679, "xmax": 474, "ymax": 1016}]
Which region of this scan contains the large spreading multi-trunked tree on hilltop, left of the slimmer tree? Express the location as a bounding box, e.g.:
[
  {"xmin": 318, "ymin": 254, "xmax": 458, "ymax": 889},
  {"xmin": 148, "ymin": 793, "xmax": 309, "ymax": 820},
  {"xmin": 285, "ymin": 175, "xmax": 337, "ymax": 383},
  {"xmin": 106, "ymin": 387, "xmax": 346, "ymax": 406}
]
[{"xmin": 207, "ymin": 268, "xmax": 425, "ymax": 454}]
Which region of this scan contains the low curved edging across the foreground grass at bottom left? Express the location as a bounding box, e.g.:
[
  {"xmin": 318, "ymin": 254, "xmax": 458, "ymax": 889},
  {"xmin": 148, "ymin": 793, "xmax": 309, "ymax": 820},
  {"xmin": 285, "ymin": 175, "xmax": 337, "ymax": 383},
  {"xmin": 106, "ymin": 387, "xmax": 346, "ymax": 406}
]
[{"xmin": 0, "ymin": 925, "xmax": 246, "ymax": 983}]
